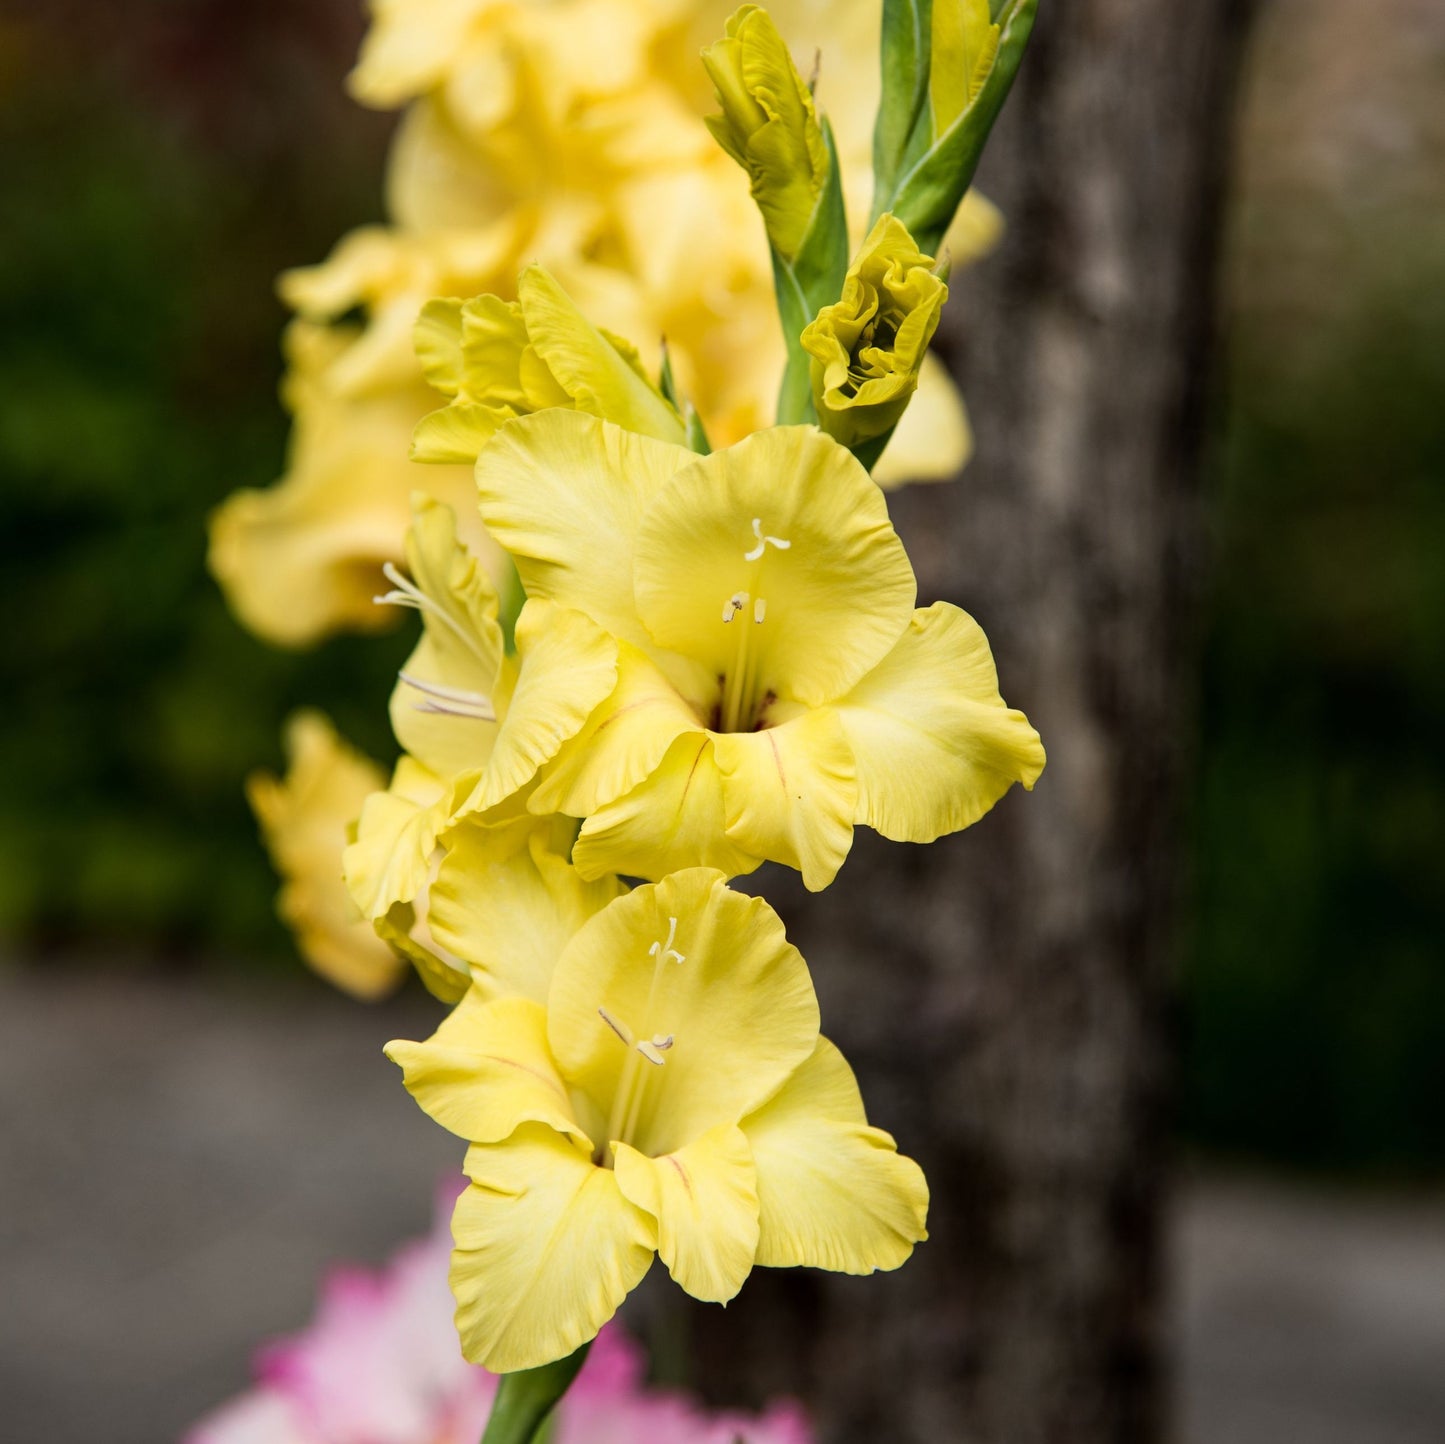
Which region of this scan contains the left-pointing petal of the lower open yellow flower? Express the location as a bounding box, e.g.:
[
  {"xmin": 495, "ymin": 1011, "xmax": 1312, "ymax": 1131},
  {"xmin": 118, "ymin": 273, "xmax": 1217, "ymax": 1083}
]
[{"xmin": 386, "ymin": 989, "xmax": 592, "ymax": 1151}]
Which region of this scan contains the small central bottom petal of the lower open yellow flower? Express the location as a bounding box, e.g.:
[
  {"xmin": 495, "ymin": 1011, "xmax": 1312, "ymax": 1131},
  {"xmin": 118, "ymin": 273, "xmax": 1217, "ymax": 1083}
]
[{"xmin": 616, "ymin": 1123, "xmax": 757, "ymax": 1304}]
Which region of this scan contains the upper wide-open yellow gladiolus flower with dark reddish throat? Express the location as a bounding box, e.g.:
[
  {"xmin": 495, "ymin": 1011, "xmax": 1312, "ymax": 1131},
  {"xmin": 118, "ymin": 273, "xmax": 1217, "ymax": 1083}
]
[{"xmin": 477, "ymin": 411, "xmax": 1043, "ymax": 890}]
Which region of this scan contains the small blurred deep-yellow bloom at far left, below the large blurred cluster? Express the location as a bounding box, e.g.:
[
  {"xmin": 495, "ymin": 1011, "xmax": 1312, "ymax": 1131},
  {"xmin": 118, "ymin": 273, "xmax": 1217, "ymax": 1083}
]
[{"xmin": 246, "ymin": 711, "xmax": 403, "ymax": 999}]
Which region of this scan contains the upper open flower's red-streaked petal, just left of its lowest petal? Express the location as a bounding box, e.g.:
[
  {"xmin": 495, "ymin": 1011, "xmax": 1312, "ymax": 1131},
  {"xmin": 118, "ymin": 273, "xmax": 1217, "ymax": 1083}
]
[{"xmin": 572, "ymin": 733, "xmax": 763, "ymax": 879}]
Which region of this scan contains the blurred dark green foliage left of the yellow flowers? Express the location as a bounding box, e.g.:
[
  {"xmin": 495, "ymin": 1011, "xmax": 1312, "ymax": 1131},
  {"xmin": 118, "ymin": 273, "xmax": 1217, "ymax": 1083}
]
[{"xmin": 0, "ymin": 4, "xmax": 400, "ymax": 957}]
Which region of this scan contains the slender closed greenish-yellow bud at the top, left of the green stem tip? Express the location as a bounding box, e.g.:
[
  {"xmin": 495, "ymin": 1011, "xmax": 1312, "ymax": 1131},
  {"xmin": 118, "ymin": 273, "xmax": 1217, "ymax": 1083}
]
[{"xmin": 702, "ymin": 4, "xmax": 828, "ymax": 260}]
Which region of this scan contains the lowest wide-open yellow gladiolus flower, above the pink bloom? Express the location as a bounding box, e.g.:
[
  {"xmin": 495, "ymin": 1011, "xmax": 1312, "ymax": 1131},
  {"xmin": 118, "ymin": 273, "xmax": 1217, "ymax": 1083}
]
[{"xmin": 387, "ymin": 869, "xmax": 928, "ymax": 1372}]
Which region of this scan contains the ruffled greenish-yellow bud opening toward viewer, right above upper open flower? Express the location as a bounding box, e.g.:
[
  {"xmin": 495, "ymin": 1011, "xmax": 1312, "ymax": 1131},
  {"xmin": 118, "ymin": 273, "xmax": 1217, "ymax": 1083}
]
[{"xmin": 802, "ymin": 215, "xmax": 948, "ymax": 451}]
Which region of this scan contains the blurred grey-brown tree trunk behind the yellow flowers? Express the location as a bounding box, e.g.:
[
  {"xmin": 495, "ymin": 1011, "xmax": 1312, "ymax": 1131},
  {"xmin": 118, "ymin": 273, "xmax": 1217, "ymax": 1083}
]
[{"xmin": 682, "ymin": 0, "xmax": 1240, "ymax": 1444}]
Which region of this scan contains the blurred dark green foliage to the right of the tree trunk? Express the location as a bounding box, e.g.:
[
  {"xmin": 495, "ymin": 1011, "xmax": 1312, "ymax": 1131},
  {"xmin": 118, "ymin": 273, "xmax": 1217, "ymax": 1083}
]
[{"xmin": 1183, "ymin": 53, "xmax": 1445, "ymax": 1174}]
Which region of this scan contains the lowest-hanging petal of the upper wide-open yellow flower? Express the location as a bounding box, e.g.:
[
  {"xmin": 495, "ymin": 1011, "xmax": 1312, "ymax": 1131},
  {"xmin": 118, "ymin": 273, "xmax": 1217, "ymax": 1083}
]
[{"xmin": 712, "ymin": 707, "xmax": 858, "ymax": 892}]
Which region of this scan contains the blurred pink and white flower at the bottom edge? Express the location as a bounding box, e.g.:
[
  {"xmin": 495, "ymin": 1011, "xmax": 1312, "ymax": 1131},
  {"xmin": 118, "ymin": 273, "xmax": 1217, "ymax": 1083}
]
[{"xmin": 184, "ymin": 1190, "xmax": 812, "ymax": 1444}]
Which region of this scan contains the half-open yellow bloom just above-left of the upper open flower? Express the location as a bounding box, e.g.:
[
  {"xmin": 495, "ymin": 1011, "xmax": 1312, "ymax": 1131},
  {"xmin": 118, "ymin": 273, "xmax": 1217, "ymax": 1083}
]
[{"xmin": 412, "ymin": 265, "xmax": 685, "ymax": 463}]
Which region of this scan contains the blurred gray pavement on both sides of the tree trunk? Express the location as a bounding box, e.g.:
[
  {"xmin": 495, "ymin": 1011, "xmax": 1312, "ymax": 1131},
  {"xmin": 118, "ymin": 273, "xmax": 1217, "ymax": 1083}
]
[{"xmin": 0, "ymin": 960, "xmax": 1445, "ymax": 1444}]
